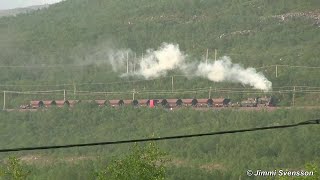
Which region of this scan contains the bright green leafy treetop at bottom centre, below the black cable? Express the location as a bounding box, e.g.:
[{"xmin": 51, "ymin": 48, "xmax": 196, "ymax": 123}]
[{"xmin": 96, "ymin": 143, "xmax": 165, "ymax": 180}]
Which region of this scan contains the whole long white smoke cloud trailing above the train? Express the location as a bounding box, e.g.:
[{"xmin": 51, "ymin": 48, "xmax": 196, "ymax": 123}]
[{"xmin": 108, "ymin": 43, "xmax": 272, "ymax": 91}]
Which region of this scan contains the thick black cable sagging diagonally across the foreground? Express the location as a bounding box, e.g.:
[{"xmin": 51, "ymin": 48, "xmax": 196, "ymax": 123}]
[{"xmin": 0, "ymin": 119, "xmax": 320, "ymax": 152}]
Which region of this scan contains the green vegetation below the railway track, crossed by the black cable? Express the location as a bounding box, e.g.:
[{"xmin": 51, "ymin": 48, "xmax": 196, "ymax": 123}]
[{"xmin": 0, "ymin": 106, "xmax": 320, "ymax": 179}]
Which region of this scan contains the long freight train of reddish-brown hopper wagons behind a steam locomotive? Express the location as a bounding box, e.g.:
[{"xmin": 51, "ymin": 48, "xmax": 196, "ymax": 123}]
[{"xmin": 20, "ymin": 97, "xmax": 276, "ymax": 109}]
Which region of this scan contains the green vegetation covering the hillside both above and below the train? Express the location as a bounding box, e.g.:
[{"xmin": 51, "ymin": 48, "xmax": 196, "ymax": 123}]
[{"xmin": 0, "ymin": 0, "xmax": 320, "ymax": 180}]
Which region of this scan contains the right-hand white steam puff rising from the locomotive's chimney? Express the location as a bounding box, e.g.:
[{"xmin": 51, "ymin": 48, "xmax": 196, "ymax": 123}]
[{"xmin": 196, "ymin": 56, "xmax": 272, "ymax": 91}]
